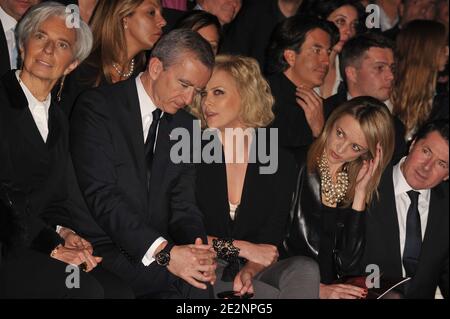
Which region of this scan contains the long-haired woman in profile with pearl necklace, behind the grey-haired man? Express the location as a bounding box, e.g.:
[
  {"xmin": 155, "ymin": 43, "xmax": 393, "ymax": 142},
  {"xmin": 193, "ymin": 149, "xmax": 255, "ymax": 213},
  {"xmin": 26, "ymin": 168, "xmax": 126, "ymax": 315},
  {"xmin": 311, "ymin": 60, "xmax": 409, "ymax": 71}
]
[{"xmin": 61, "ymin": 0, "xmax": 166, "ymax": 116}]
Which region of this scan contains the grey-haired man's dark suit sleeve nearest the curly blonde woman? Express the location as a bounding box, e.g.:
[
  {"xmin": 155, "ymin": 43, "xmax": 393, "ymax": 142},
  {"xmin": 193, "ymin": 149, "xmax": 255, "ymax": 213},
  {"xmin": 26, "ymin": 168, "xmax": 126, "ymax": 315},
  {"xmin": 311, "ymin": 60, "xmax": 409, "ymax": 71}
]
[{"xmin": 169, "ymin": 164, "xmax": 207, "ymax": 244}]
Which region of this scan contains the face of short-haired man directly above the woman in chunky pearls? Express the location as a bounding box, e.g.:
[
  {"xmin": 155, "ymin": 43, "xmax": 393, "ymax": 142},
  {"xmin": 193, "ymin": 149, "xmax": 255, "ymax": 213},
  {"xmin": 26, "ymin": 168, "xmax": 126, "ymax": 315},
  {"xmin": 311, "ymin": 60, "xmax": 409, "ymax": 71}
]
[{"xmin": 346, "ymin": 47, "xmax": 395, "ymax": 102}]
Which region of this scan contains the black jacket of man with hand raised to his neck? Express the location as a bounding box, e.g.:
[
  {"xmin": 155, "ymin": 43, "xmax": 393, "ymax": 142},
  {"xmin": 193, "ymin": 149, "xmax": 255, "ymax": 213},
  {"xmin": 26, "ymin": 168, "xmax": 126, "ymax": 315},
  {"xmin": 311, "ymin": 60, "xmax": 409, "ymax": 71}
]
[{"xmin": 268, "ymin": 73, "xmax": 331, "ymax": 148}]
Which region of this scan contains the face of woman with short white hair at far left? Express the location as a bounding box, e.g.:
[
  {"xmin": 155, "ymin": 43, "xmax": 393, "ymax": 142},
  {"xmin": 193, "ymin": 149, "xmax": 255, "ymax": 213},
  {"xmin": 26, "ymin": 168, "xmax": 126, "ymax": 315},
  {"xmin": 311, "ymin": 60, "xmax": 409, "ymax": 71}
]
[{"xmin": 21, "ymin": 17, "xmax": 78, "ymax": 82}]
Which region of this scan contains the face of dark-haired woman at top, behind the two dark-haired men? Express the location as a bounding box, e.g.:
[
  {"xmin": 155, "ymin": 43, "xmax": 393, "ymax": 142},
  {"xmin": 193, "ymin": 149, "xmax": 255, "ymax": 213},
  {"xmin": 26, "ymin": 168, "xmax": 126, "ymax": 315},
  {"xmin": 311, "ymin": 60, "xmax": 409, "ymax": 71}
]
[{"xmin": 327, "ymin": 5, "xmax": 359, "ymax": 53}]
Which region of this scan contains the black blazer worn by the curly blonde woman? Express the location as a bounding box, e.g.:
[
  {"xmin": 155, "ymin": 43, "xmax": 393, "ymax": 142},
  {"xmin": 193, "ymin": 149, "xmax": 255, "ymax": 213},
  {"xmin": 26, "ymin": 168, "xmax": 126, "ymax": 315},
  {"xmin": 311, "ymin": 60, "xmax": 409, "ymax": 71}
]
[{"xmin": 196, "ymin": 134, "xmax": 297, "ymax": 246}]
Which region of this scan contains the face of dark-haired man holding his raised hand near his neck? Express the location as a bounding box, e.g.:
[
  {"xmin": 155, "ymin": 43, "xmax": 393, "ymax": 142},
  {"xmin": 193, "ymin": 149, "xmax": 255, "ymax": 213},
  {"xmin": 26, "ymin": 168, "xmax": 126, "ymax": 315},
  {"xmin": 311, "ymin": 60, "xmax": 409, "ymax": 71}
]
[{"xmin": 285, "ymin": 29, "xmax": 331, "ymax": 88}]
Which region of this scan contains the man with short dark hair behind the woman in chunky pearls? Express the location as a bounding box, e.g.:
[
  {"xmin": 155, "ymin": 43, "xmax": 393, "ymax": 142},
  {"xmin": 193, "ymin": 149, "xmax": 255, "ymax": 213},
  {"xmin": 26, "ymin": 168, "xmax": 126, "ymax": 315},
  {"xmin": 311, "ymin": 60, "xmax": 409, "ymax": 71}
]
[{"xmin": 324, "ymin": 33, "xmax": 406, "ymax": 161}]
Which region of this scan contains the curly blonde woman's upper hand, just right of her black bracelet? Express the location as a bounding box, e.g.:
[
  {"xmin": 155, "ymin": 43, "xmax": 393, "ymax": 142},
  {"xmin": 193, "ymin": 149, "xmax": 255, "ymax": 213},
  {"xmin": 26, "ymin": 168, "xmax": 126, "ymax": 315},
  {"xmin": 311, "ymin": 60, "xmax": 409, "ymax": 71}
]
[{"xmin": 234, "ymin": 240, "xmax": 279, "ymax": 267}]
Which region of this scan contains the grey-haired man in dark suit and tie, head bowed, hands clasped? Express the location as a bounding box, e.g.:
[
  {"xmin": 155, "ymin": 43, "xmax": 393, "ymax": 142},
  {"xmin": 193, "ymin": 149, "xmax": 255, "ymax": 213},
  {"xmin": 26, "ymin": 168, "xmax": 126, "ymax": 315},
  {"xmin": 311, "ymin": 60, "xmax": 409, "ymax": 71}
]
[{"xmin": 71, "ymin": 29, "xmax": 215, "ymax": 298}]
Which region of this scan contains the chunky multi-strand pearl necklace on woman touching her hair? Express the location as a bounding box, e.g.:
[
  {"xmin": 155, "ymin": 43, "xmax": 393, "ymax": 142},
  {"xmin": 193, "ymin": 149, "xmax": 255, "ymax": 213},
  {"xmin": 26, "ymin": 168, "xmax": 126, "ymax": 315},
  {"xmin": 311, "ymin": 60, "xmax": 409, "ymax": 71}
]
[{"xmin": 317, "ymin": 151, "xmax": 348, "ymax": 206}]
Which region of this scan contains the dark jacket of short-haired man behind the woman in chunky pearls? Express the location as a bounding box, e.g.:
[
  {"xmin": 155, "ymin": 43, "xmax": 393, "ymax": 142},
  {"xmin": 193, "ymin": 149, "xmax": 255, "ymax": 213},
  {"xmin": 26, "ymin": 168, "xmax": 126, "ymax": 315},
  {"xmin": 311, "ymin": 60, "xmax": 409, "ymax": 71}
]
[{"xmin": 324, "ymin": 90, "xmax": 407, "ymax": 163}]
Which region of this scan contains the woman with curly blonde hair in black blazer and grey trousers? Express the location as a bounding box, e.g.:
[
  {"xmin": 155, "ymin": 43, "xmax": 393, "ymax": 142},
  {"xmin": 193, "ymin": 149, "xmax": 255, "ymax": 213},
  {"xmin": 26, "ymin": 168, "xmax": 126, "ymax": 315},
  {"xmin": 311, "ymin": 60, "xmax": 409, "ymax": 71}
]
[{"xmin": 195, "ymin": 55, "xmax": 319, "ymax": 299}]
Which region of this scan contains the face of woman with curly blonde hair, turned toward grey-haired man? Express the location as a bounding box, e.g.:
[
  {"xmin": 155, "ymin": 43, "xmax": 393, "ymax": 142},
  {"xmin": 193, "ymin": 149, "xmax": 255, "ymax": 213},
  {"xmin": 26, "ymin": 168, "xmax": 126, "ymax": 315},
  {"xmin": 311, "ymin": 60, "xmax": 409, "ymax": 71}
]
[{"xmin": 201, "ymin": 70, "xmax": 243, "ymax": 131}]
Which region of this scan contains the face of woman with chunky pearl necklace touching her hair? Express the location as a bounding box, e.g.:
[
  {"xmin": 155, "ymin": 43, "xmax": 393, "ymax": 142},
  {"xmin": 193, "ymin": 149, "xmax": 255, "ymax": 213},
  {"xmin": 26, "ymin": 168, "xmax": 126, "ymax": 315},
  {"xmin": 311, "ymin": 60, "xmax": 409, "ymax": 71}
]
[{"xmin": 325, "ymin": 114, "xmax": 368, "ymax": 165}]
